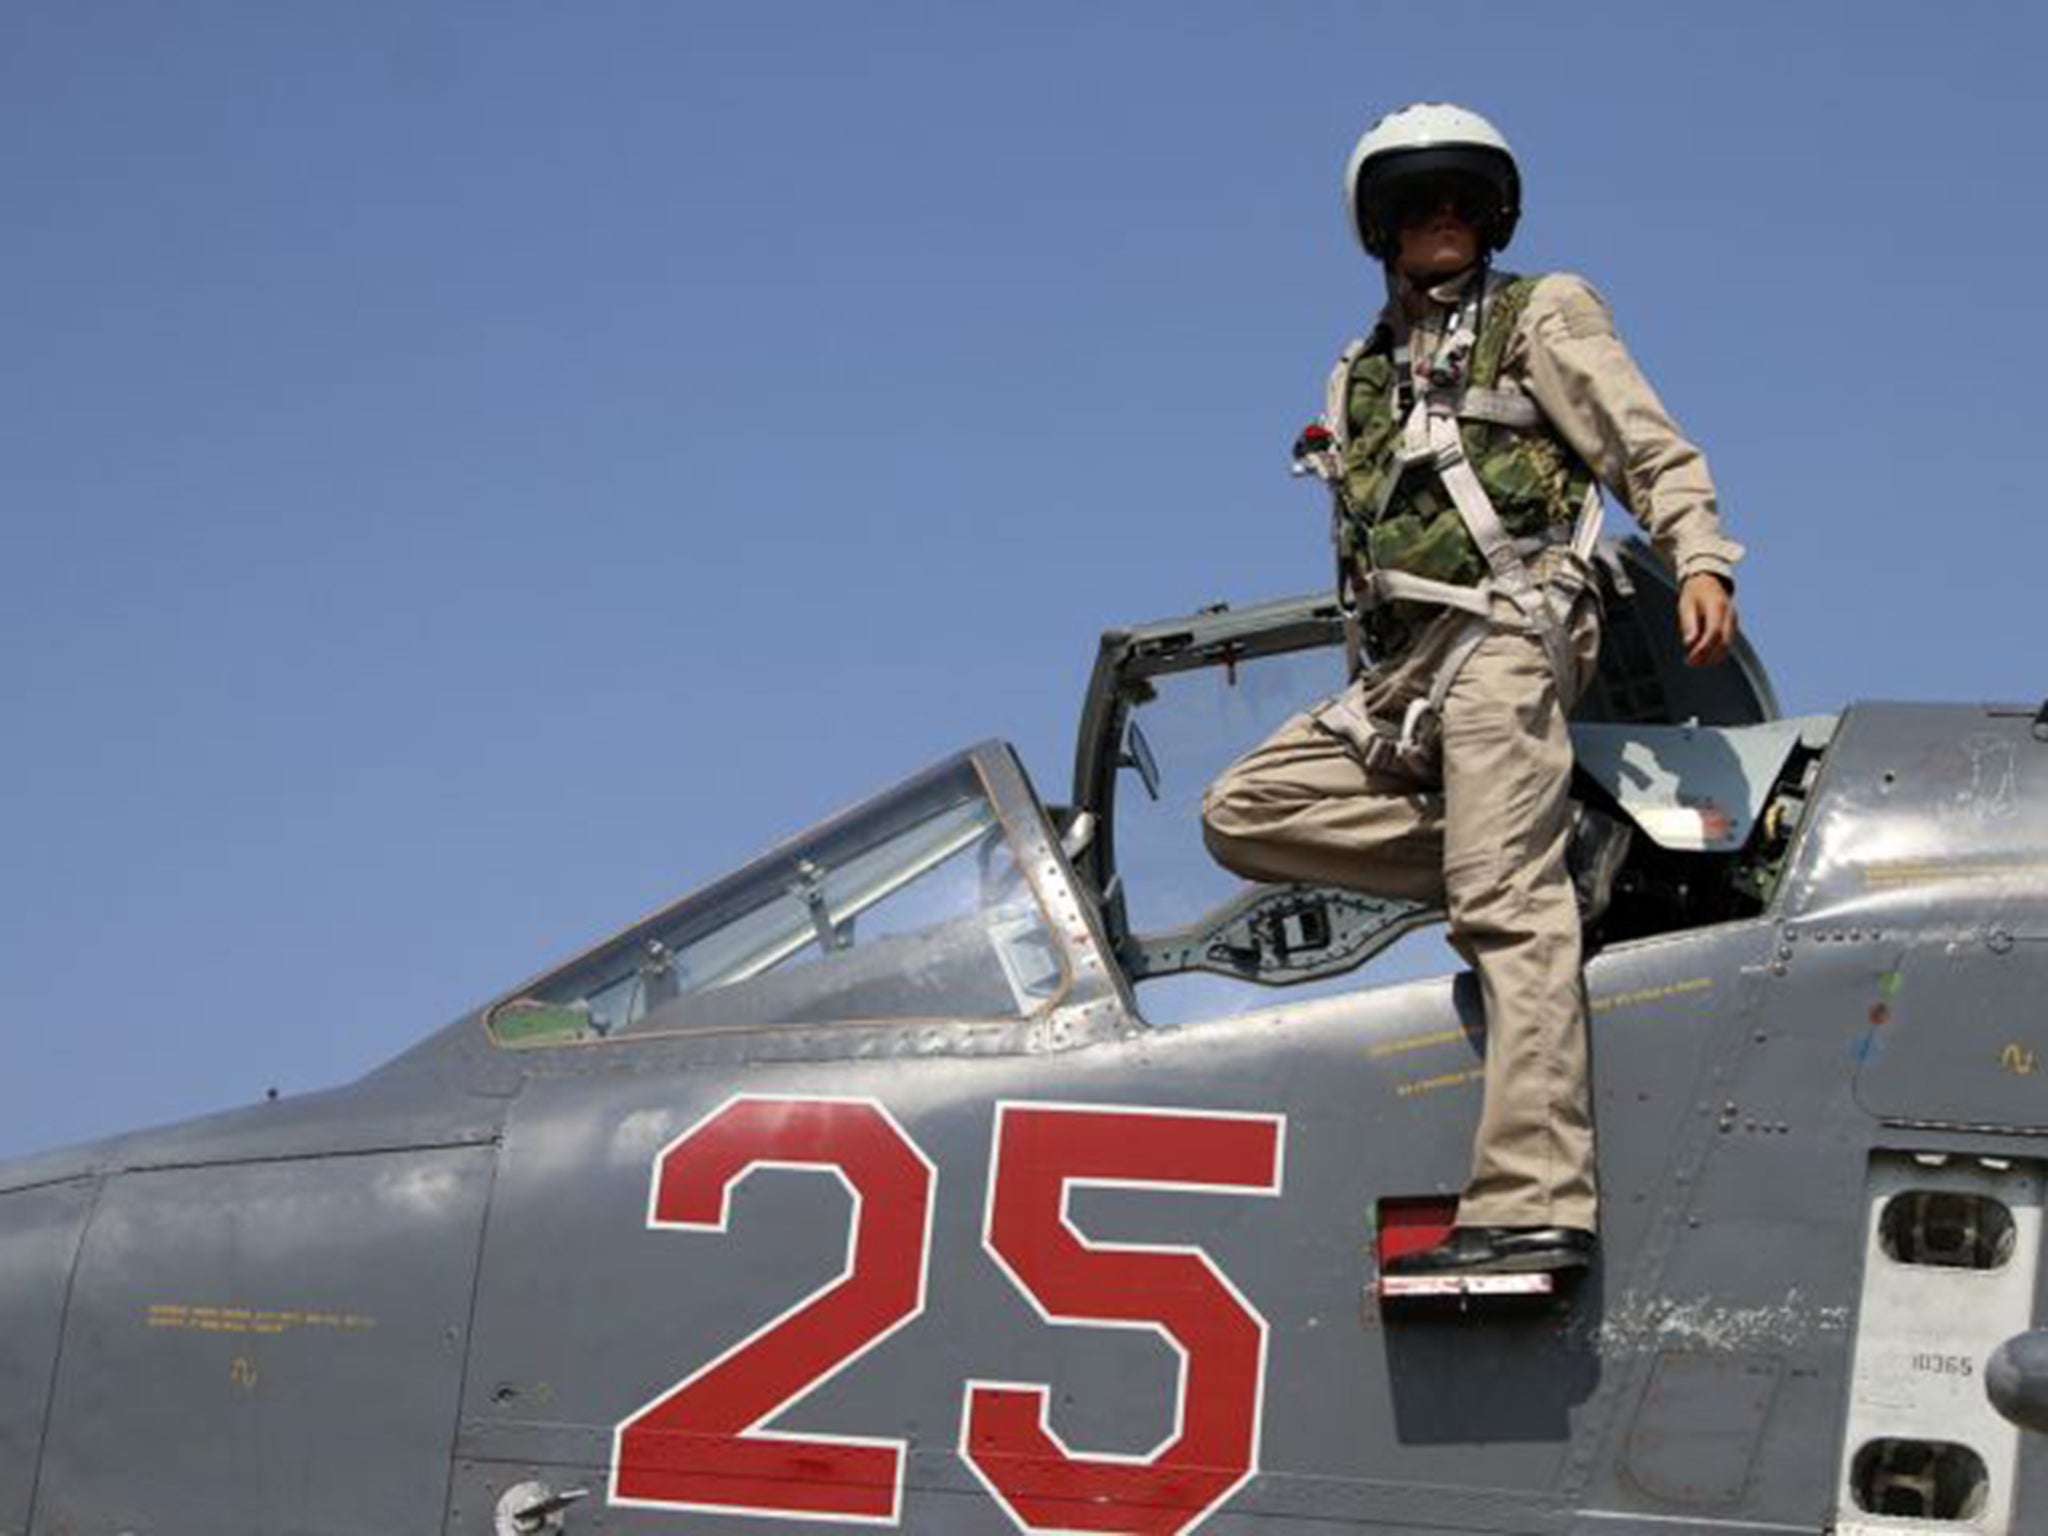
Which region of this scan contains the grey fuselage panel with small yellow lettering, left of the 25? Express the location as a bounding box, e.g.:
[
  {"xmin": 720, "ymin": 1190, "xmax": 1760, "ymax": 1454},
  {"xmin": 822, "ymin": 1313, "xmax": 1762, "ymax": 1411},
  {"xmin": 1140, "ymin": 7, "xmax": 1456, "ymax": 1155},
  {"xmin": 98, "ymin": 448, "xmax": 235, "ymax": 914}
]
[{"xmin": 35, "ymin": 1147, "xmax": 494, "ymax": 1536}]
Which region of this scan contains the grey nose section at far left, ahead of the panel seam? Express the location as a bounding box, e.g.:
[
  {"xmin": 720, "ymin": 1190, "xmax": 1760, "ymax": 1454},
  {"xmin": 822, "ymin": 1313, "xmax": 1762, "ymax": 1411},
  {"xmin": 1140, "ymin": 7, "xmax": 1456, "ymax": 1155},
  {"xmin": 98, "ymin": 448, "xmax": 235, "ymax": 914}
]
[{"xmin": 0, "ymin": 1180, "xmax": 92, "ymax": 1530}]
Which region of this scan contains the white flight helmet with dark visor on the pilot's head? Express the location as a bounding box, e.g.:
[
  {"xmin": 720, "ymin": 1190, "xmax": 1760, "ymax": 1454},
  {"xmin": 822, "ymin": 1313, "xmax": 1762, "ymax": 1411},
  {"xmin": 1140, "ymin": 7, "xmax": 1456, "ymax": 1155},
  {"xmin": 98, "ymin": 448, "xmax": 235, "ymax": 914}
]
[{"xmin": 1343, "ymin": 100, "xmax": 1522, "ymax": 262}]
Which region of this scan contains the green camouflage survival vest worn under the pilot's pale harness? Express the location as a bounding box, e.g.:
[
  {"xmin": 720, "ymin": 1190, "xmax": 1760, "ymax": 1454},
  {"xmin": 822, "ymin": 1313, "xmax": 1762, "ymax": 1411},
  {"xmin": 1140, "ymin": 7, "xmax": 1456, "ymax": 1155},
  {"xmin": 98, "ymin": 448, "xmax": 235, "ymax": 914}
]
[{"xmin": 1329, "ymin": 274, "xmax": 1593, "ymax": 649}]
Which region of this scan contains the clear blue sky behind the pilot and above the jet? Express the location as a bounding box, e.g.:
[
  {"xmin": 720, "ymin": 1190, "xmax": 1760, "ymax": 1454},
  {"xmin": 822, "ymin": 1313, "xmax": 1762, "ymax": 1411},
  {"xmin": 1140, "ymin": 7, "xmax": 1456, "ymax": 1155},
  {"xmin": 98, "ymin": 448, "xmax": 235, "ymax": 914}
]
[{"xmin": 0, "ymin": 0, "xmax": 2048, "ymax": 1153}]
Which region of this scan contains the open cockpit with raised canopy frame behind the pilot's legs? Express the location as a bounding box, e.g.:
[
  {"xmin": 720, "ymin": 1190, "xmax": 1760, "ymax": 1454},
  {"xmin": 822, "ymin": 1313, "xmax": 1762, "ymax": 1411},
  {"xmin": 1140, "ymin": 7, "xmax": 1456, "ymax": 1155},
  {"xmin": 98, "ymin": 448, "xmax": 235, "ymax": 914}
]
[{"xmin": 1075, "ymin": 543, "xmax": 1833, "ymax": 1022}]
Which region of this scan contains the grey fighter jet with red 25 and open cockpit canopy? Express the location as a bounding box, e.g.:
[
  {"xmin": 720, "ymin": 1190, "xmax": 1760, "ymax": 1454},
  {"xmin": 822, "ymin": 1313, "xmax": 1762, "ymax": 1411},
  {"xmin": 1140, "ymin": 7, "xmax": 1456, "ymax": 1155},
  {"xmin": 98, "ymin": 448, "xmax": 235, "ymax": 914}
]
[{"xmin": 0, "ymin": 547, "xmax": 2048, "ymax": 1536}]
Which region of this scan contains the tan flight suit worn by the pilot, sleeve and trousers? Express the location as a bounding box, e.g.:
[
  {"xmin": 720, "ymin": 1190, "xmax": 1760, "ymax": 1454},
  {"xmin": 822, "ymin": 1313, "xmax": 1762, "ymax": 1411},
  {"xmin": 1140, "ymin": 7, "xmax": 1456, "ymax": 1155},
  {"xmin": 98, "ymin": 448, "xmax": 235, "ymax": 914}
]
[{"xmin": 1202, "ymin": 274, "xmax": 1743, "ymax": 1231}]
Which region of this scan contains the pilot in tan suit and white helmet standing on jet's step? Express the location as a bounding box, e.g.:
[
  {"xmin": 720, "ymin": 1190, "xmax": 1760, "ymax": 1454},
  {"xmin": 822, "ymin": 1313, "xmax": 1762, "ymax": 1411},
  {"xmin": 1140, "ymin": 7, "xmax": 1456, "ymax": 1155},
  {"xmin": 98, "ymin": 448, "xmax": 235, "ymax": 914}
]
[{"xmin": 1202, "ymin": 102, "xmax": 1743, "ymax": 1276}]
